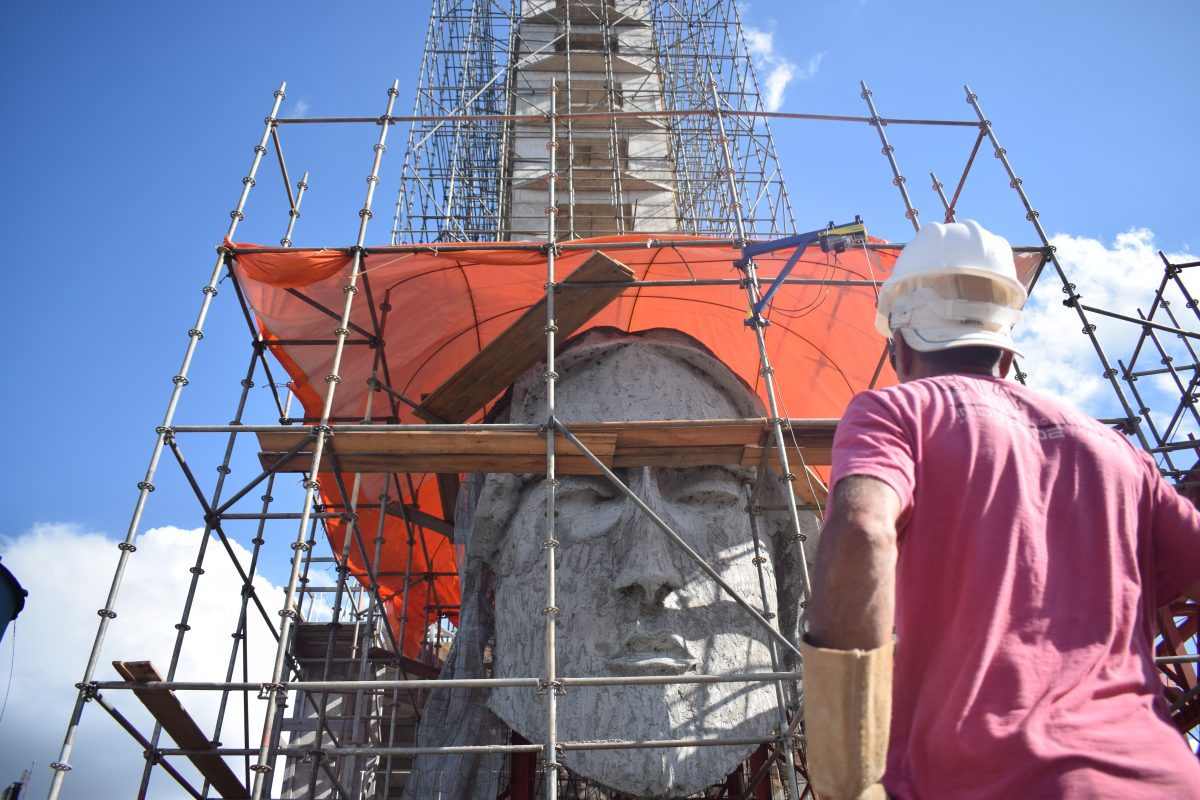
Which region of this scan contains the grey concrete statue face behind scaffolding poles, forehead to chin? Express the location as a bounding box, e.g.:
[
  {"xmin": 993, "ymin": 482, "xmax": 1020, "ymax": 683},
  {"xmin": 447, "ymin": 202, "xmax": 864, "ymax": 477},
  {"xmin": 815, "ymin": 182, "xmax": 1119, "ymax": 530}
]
[{"xmin": 470, "ymin": 337, "xmax": 806, "ymax": 798}]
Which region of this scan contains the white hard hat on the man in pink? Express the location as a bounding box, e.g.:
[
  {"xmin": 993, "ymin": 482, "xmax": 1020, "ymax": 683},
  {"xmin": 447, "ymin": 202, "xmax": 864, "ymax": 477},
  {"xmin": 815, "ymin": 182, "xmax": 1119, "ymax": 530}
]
[{"xmin": 875, "ymin": 219, "xmax": 1027, "ymax": 355}]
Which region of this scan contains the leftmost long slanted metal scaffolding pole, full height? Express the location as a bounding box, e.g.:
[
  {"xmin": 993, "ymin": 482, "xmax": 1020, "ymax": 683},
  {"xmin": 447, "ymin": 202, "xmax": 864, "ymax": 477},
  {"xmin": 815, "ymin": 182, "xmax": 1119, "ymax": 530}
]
[{"xmin": 47, "ymin": 83, "xmax": 287, "ymax": 800}]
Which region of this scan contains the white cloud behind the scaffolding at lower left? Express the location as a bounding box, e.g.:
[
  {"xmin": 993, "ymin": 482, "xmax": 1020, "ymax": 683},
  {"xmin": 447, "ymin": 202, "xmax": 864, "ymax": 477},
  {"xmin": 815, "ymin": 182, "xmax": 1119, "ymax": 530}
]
[{"xmin": 0, "ymin": 524, "xmax": 283, "ymax": 800}]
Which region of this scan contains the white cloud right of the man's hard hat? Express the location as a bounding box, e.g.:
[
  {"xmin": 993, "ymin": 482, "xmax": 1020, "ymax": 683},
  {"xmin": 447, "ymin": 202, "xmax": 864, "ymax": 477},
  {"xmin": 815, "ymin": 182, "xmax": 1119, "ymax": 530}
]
[{"xmin": 1016, "ymin": 228, "xmax": 1196, "ymax": 448}]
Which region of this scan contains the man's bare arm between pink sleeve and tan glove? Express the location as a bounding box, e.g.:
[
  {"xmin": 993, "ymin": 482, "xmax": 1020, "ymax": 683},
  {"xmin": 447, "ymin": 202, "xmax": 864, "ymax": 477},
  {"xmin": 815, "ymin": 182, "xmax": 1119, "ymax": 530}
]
[{"xmin": 808, "ymin": 475, "xmax": 900, "ymax": 650}]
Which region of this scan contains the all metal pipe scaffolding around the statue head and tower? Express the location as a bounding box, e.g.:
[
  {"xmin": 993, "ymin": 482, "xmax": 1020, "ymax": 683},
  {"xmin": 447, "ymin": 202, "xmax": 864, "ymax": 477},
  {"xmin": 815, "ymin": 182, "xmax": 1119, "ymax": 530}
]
[{"xmin": 49, "ymin": 0, "xmax": 1200, "ymax": 800}]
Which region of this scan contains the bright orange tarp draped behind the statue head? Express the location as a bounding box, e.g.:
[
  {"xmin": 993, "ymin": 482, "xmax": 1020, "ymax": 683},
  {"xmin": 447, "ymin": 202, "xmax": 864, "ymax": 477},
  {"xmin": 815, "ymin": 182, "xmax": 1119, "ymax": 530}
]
[{"xmin": 234, "ymin": 235, "xmax": 1037, "ymax": 656}]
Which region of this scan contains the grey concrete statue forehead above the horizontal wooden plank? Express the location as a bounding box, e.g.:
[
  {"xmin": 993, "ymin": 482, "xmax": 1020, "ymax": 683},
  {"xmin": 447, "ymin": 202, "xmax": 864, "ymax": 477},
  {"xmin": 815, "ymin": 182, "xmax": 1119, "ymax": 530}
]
[{"xmin": 512, "ymin": 342, "xmax": 752, "ymax": 422}]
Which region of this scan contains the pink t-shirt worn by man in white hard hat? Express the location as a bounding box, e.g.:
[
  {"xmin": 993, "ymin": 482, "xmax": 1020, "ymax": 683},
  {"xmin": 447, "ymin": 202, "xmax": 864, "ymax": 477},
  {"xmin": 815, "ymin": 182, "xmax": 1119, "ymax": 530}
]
[{"xmin": 833, "ymin": 374, "xmax": 1200, "ymax": 800}]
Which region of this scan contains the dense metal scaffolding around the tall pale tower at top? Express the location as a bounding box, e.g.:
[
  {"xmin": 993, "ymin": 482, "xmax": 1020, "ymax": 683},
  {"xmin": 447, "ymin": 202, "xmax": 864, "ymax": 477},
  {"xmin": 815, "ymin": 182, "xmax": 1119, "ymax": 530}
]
[{"xmin": 392, "ymin": 0, "xmax": 796, "ymax": 243}]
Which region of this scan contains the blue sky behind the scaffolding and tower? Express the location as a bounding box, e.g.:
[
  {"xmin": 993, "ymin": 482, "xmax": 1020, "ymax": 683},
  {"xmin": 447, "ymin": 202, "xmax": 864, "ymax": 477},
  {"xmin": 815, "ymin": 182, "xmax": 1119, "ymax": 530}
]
[{"xmin": 0, "ymin": 0, "xmax": 1200, "ymax": 796}]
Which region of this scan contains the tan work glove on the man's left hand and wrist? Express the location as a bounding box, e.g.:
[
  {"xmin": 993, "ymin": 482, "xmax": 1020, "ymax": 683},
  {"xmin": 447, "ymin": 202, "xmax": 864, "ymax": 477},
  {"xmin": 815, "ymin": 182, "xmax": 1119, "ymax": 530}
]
[{"xmin": 800, "ymin": 642, "xmax": 895, "ymax": 800}]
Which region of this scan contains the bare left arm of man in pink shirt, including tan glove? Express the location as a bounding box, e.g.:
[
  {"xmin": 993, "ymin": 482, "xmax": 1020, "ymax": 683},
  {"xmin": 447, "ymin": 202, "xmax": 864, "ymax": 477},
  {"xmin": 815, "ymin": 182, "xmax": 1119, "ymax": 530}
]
[{"xmin": 800, "ymin": 475, "xmax": 900, "ymax": 800}]
